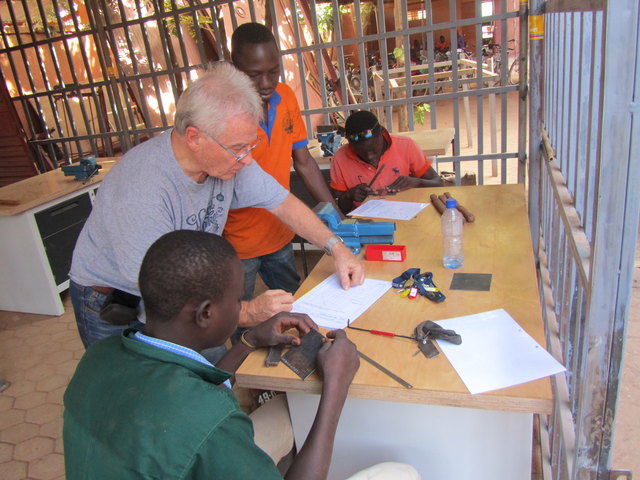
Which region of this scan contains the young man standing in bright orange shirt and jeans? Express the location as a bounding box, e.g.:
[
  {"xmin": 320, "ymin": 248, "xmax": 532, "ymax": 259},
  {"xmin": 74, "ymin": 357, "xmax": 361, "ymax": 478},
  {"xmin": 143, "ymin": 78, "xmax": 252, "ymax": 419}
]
[{"xmin": 224, "ymin": 23, "xmax": 333, "ymax": 304}]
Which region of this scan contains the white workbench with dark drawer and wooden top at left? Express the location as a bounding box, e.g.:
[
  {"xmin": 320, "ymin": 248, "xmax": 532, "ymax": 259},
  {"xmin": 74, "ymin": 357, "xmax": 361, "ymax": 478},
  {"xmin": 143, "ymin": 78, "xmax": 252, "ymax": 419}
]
[{"xmin": 0, "ymin": 158, "xmax": 116, "ymax": 315}]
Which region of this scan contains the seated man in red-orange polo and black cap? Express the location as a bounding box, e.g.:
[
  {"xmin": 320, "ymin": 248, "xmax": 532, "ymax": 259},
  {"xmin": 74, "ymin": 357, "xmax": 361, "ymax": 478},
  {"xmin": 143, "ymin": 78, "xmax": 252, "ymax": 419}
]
[{"xmin": 329, "ymin": 110, "xmax": 443, "ymax": 214}]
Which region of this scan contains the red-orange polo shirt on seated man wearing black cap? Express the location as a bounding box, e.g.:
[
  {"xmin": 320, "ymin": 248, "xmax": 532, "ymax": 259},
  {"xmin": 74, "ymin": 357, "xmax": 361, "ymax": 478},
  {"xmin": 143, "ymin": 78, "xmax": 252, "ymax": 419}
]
[{"xmin": 329, "ymin": 129, "xmax": 431, "ymax": 206}]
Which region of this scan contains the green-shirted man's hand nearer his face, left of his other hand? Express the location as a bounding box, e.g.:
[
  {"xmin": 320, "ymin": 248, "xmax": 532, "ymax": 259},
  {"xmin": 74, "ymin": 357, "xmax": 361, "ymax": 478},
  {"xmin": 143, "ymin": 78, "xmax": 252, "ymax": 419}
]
[{"xmin": 245, "ymin": 312, "xmax": 318, "ymax": 348}]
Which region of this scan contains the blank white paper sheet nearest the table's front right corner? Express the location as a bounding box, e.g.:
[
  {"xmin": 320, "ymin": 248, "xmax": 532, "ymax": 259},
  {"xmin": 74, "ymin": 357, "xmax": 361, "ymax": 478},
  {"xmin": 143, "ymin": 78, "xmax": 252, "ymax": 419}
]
[{"xmin": 436, "ymin": 309, "xmax": 565, "ymax": 394}]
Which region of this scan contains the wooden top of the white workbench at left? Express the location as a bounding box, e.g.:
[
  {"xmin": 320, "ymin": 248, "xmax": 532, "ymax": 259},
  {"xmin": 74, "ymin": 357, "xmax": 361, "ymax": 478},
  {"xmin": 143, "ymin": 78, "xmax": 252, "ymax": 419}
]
[{"xmin": 0, "ymin": 157, "xmax": 118, "ymax": 216}]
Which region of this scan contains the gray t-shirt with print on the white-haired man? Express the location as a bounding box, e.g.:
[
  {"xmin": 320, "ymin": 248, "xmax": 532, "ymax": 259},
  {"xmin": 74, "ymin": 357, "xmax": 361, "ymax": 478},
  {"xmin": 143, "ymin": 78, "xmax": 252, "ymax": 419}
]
[{"xmin": 69, "ymin": 129, "xmax": 289, "ymax": 295}]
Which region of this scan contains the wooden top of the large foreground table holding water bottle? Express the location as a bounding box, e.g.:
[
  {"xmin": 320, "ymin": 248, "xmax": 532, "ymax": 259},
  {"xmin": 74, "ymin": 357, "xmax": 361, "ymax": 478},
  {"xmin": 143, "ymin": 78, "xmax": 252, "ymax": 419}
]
[{"xmin": 236, "ymin": 185, "xmax": 552, "ymax": 413}]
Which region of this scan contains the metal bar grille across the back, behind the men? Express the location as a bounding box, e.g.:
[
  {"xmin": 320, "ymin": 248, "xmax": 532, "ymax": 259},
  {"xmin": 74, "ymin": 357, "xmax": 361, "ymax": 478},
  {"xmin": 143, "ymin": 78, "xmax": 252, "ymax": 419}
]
[{"xmin": 0, "ymin": 0, "xmax": 527, "ymax": 183}]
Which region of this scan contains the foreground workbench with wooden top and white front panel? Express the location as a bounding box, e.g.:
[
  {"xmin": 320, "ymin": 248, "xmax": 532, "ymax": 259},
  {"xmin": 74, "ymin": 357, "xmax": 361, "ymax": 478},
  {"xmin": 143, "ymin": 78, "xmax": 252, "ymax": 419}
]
[{"xmin": 237, "ymin": 185, "xmax": 552, "ymax": 479}]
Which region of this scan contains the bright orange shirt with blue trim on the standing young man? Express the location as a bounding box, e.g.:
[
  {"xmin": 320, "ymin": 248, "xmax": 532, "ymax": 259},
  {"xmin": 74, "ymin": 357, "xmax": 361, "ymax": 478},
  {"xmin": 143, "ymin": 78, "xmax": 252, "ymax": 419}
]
[{"xmin": 224, "ymin": 83, "xmax": 309, "ymax": 259}]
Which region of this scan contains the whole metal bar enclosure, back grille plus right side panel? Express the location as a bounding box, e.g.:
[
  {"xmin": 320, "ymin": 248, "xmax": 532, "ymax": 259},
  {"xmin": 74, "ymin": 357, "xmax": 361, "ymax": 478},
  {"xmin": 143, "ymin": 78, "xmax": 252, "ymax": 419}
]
[{"xmin": 0, "ymin": 0, "xmax": 640, "ymax": 479}]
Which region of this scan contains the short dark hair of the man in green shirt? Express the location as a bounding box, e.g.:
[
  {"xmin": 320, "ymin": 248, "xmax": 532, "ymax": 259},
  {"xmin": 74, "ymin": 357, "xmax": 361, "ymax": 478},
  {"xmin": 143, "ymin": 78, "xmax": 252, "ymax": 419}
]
[{"xmin": 138, "ymin": 230, "xmax": 239, "ymax": 321}]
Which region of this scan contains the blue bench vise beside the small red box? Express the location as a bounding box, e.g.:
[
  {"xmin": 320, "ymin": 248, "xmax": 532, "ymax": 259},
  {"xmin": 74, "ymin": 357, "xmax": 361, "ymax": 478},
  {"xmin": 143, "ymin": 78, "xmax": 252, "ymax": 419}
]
[{"xmin": 313, "ymin": 202, "xmax": 396, "ymax": 254}]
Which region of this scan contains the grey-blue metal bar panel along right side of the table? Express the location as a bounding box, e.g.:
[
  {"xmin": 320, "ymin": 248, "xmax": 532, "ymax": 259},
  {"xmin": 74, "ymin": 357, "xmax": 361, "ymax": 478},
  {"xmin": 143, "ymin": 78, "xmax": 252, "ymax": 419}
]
[{"xmin": 529, "ymin": 0, "xmax": 640, "ymax": 479}]
